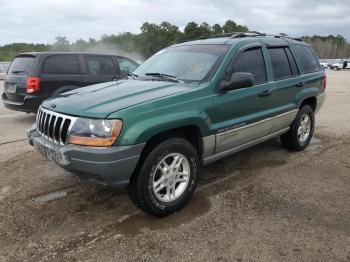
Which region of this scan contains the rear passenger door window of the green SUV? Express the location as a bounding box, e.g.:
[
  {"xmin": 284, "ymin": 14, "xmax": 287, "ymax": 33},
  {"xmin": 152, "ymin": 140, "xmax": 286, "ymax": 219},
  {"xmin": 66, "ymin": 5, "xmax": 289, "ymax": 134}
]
[{"xmin": 268, "ymin": 47, "xmax": 292, "ymax": 80}]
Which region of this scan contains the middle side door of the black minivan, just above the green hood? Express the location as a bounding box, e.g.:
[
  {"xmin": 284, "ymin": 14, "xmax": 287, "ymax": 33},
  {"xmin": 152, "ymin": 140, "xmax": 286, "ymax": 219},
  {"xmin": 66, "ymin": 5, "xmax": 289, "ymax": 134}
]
[{"xmin": 83, "ymin": 55, "xmax": 117, "ymax": 85}]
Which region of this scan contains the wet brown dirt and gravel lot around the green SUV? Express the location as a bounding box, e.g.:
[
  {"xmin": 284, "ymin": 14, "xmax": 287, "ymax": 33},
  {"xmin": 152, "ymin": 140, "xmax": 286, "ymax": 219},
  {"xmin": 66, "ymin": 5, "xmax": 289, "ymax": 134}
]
[{"xmin": 0, "ymin": 72, "xmax": 350, "ymax": 261}]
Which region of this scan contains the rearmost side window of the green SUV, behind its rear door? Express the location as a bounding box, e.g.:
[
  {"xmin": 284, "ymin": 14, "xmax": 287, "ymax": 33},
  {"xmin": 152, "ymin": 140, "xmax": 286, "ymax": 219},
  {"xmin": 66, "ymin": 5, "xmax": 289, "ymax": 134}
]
[{"xmin": 293, "ymin": 45, "xmax": 320, "ymax": 74}]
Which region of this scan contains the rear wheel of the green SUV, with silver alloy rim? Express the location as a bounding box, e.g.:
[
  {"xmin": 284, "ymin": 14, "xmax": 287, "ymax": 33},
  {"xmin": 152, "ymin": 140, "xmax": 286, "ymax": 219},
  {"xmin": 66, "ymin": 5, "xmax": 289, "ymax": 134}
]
[{"xmin": 281, "ymin": 105, "xmax": 315, "ymax": 151}]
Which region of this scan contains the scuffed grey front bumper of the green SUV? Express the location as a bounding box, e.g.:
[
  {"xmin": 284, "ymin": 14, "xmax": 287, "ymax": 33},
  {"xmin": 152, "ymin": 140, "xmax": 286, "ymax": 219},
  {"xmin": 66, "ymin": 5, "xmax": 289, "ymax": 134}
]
[{"xmin": 28, "ymin": 125, "xmax": 145, "ymax": 187}]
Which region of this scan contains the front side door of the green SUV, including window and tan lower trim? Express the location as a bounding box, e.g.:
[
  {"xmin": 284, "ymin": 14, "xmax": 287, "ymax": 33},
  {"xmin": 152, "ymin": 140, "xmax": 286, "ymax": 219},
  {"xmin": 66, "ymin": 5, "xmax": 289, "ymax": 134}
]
[{"xmin": 213, "ymin": 43, "xmax": 272, "ymax": 154}]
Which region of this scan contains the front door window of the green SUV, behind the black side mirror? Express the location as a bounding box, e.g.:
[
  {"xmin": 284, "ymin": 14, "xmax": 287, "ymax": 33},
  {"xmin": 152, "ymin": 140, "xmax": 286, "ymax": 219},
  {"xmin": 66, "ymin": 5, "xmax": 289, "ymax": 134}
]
[{"xmin": 232, "ymin": 48, "xmax": 266, "ymax": 84}]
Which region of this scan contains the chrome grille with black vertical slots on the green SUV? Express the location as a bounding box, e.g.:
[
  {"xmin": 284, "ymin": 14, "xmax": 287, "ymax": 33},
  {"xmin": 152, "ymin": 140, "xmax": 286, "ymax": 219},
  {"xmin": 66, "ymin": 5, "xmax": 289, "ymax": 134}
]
[{"xmin": 36, "ymin": 107, "xmax": 77, "ymax": 145}]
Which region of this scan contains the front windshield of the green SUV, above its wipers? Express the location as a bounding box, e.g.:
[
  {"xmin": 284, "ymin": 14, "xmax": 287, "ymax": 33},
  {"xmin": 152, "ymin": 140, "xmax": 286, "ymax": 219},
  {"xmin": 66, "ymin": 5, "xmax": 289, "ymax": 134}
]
[{"xmin": 133, "ymin": 45, "xmax": 229, "ymax": 81}]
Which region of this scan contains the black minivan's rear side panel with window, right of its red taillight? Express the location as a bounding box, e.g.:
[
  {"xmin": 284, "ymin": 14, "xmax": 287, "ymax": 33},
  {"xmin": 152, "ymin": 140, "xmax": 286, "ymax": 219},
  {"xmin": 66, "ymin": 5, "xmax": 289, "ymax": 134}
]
[{"xmin": 40, "ymin": 54, "xmax": 83, "ymax": 98}]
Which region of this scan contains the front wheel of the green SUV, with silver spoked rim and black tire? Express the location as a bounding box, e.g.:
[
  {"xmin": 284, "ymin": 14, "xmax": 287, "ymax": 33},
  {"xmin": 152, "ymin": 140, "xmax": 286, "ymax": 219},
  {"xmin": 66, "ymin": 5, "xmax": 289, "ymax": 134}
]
[{"xmin": 128, "ymin": 138, "xmax": 199, "ymax": 217}]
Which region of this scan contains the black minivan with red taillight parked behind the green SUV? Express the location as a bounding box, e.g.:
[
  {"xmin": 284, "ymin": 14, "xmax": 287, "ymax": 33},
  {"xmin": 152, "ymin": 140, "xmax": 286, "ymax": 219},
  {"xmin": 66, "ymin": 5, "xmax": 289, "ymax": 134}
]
[{"xmin": 2, "ymin": 52, "xmax": 139, "ymax": 113}]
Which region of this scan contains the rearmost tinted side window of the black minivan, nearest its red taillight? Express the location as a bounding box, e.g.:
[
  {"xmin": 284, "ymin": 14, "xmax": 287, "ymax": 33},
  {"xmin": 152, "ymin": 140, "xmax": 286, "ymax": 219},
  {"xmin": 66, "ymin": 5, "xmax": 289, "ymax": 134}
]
[{"xmin": 43, "ymin": 55, "xmax": 81, "ymax": 74}]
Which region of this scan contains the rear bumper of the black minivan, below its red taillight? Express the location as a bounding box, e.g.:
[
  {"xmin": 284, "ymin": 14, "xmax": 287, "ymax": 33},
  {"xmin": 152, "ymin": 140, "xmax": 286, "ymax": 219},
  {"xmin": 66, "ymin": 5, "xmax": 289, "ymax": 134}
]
[{"xmin": 2, "ymin": 93, "xmax": 44, "ymax": 113}]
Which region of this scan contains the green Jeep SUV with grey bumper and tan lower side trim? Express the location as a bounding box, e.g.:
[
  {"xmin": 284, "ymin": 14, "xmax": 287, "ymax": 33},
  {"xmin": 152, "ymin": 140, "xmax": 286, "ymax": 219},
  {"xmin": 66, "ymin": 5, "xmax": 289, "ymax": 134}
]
[{"xmin": 28, "ymin": 32, "xmax": 326, "ymax": 216}]
